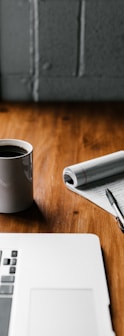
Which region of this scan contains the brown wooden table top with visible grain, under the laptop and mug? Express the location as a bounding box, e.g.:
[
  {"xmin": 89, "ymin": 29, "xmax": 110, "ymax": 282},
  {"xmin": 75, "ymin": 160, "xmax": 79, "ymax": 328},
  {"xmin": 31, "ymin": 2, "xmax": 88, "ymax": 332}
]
[{"xmin": 0, "ymin": 102, "xmax": 124, "ymax": 336}]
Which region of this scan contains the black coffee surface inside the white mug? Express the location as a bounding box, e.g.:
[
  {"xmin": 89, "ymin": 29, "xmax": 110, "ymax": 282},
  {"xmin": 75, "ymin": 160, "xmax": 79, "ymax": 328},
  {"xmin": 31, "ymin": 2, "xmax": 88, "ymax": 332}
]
[{"xmin": 0, "ymin": 145, "xmax": 27, "ymax": 158}]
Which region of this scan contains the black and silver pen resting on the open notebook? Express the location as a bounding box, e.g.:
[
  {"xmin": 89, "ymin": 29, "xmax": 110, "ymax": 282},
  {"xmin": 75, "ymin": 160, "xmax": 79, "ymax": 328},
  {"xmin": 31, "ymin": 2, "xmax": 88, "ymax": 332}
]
[{"xmin": 106, "ymin": 189, "xmax": 124, "ymax": 230}]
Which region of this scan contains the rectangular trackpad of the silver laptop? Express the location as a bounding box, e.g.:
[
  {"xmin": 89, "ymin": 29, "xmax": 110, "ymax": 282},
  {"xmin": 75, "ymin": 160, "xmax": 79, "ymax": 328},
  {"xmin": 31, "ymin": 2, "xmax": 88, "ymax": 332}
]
[{"xmin": 28, "ymin": 289, "xmax": 98, "ymax": 336}]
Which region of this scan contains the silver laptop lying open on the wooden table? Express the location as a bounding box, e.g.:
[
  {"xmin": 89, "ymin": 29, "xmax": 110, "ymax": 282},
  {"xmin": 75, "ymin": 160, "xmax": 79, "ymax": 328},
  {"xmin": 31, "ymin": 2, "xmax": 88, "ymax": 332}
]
[{"xmin": 0, "ymin": 233, "xmax": 115, "ymax": 336}]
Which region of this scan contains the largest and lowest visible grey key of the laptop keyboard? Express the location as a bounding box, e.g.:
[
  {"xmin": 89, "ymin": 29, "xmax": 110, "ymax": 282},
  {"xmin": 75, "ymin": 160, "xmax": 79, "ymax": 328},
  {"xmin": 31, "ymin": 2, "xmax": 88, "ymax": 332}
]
[{"xmin": 0, "ymin": 297, "xmax": 12, "ymax": 336}]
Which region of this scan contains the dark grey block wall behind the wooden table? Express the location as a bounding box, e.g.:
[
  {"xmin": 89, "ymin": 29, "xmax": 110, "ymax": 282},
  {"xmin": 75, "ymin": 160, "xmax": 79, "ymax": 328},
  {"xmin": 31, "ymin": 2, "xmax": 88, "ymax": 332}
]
[{"xmin": 0, "ymin": 0, "xmax": 124, "ymax": 101}]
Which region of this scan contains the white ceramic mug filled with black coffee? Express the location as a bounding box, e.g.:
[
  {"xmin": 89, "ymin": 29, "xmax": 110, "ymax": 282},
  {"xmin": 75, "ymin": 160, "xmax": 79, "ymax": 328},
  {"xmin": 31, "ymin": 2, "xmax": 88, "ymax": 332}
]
[{"xmin": 0, "ymin": 139, "xmax": 33, "ymax": 213}]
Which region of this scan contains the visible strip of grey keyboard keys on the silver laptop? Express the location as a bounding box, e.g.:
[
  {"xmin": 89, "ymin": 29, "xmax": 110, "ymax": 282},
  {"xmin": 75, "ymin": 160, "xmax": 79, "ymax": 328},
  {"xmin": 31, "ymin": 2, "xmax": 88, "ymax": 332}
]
[{"xmin": 0, "ymin": 249, "xmax": 18, "ymax": 336}]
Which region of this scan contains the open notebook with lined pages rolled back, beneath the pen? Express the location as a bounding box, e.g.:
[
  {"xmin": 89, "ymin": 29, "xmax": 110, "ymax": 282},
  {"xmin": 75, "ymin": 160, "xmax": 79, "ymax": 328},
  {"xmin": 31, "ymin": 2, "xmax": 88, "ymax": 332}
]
[{"xmin": 63, "ymin": 151, "xmax": 124, "ymax": 216}]
